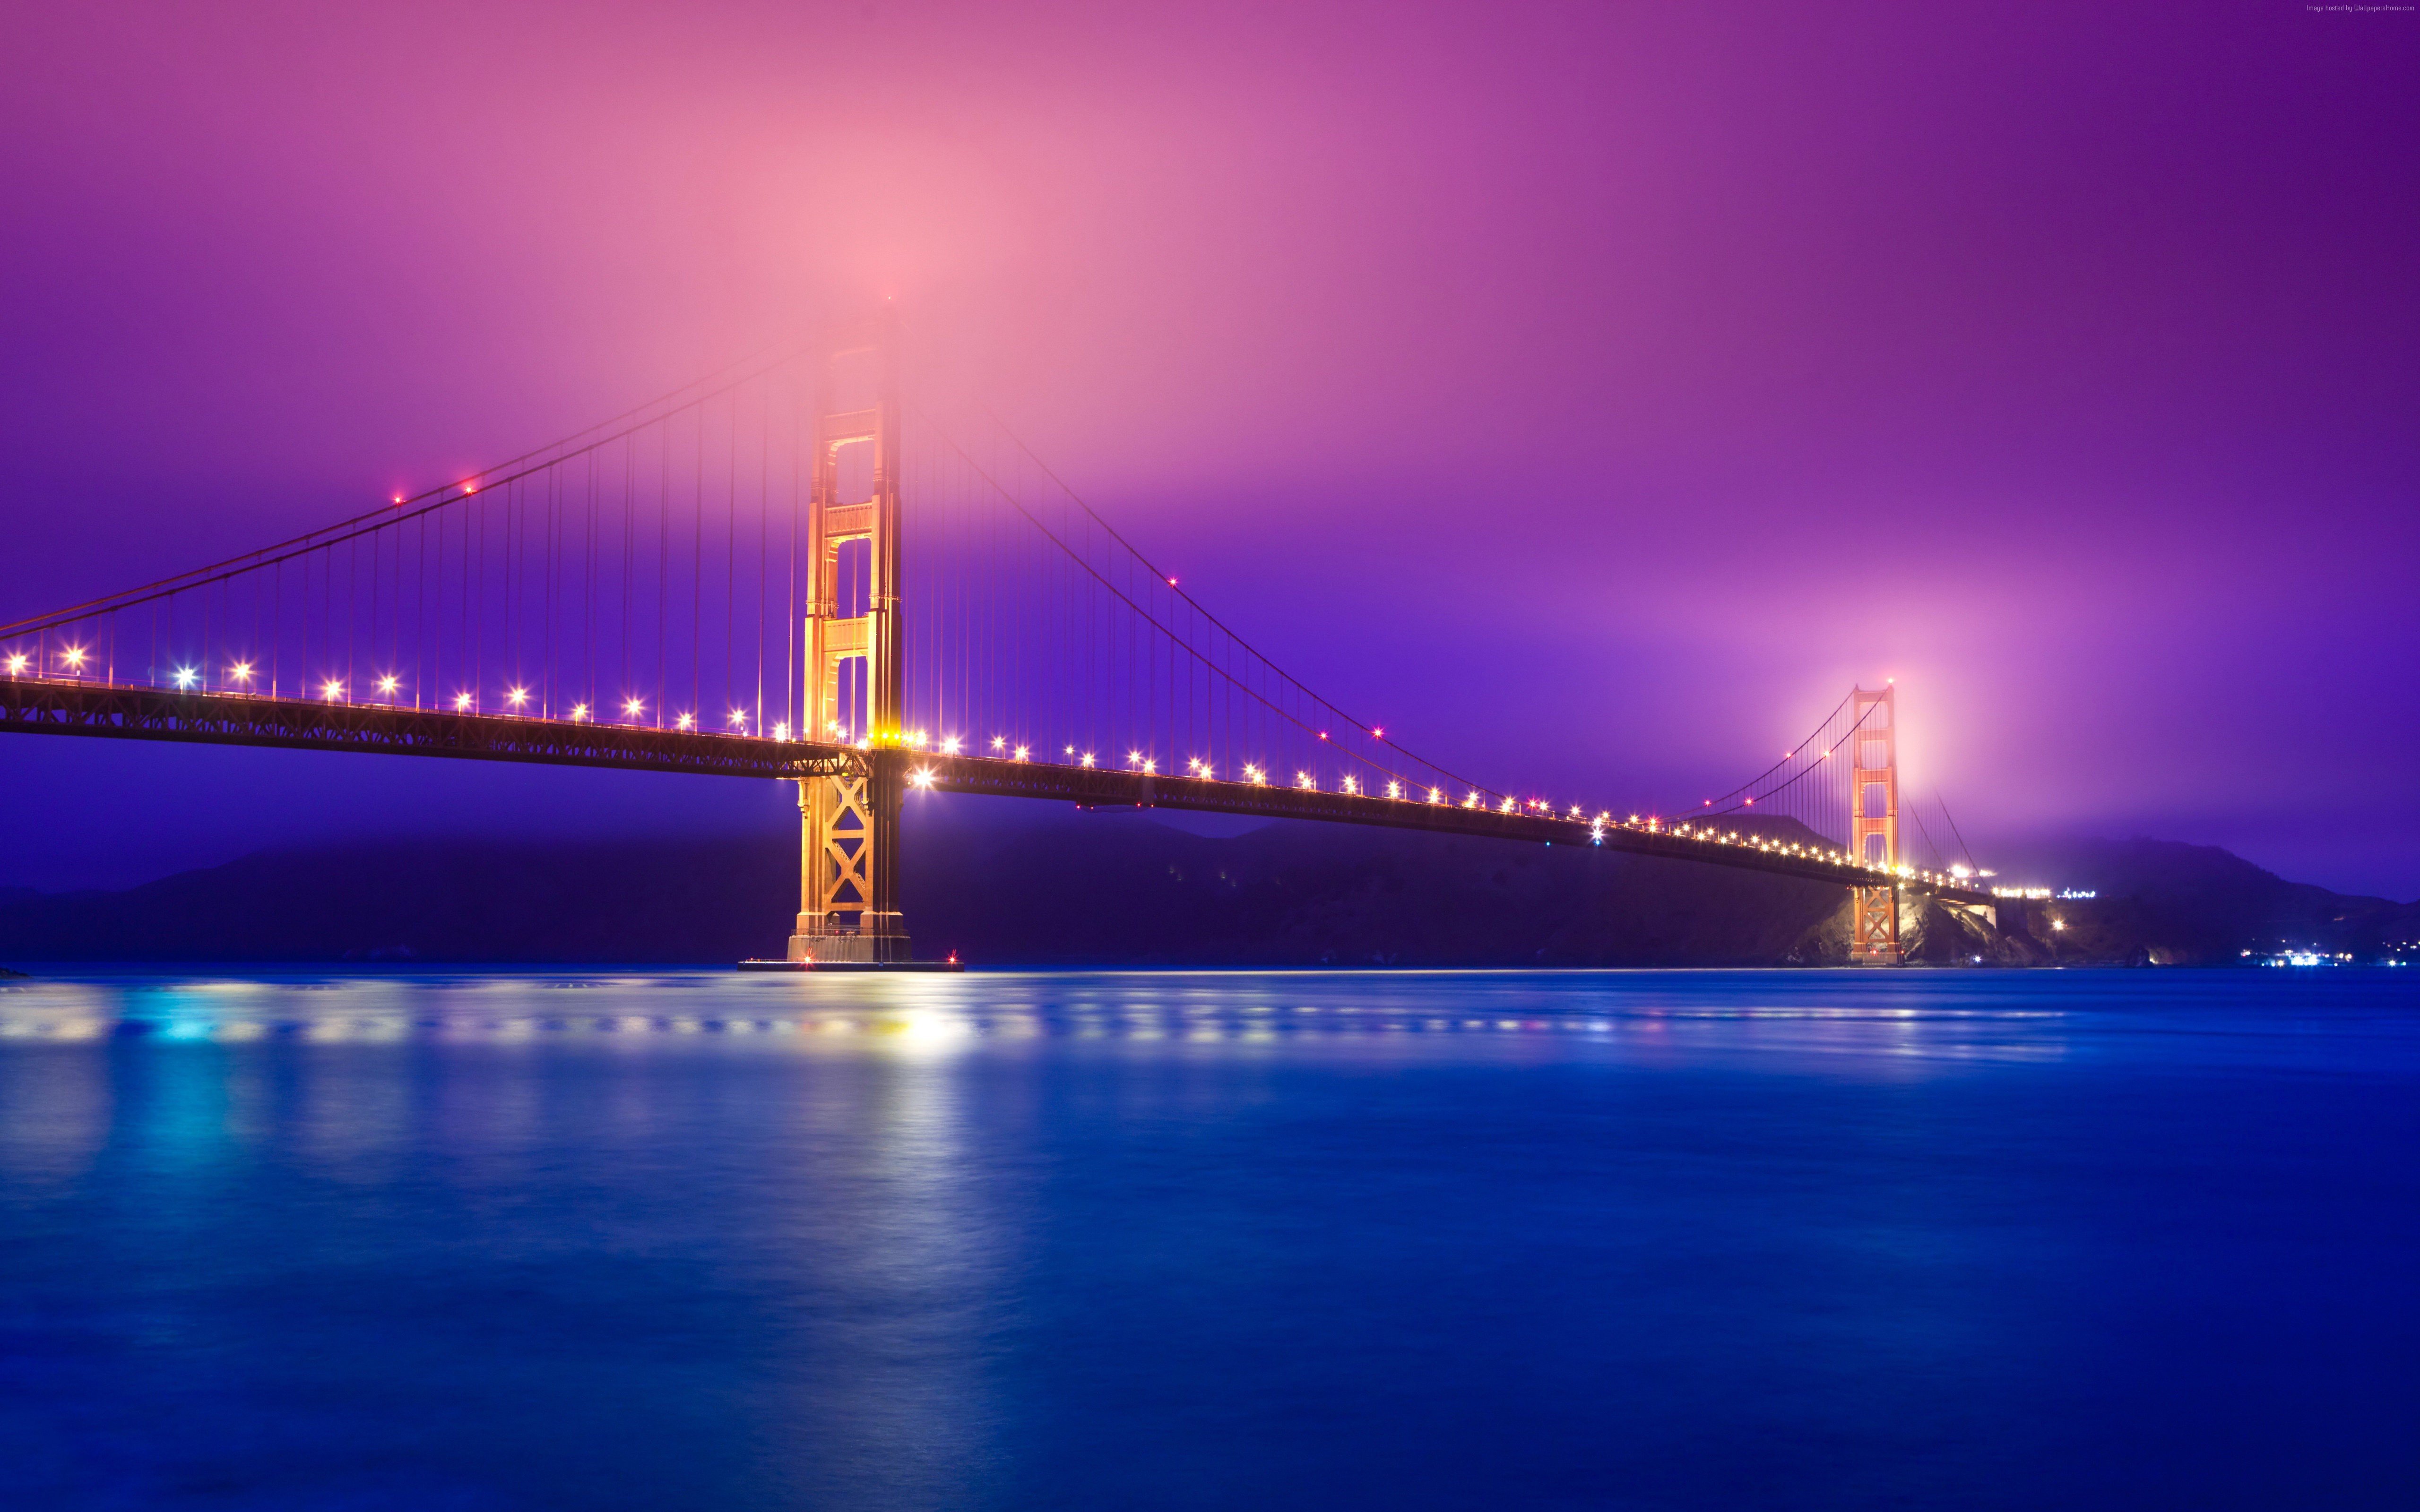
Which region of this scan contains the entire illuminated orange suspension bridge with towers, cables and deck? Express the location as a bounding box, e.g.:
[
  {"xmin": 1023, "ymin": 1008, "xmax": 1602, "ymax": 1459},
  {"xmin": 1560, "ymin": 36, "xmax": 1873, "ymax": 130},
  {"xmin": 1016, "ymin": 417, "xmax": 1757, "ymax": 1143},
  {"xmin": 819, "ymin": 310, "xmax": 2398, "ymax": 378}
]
[{"xmin": 0, "ymin": 315, "xmax": 1994, "ymax": 968}]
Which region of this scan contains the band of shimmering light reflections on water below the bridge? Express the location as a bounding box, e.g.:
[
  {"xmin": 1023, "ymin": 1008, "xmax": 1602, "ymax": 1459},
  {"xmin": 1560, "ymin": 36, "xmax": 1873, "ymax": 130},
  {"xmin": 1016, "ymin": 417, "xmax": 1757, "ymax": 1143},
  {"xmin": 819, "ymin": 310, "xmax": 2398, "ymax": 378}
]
[{"xmin": 0, "ymin": 972, "xmax": 2069, "ymax": 1055}]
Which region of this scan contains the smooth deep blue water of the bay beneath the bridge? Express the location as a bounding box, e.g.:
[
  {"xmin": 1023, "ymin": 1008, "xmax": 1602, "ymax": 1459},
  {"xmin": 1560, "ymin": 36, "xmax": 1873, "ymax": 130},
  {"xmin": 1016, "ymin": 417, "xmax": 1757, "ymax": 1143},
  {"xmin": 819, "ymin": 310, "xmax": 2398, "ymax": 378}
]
[{"xmin": 0, "ymin": 970, "xmax": 2420, "ymax": 1510}]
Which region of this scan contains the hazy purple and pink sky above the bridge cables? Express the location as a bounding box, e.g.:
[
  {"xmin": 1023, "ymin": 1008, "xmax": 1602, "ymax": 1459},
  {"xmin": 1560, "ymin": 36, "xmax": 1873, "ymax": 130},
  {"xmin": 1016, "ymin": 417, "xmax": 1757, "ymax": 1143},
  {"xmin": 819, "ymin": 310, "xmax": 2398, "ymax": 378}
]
[{"xmin": 0, "ymin": 0, "xmax": 2420, "ymax": 898}]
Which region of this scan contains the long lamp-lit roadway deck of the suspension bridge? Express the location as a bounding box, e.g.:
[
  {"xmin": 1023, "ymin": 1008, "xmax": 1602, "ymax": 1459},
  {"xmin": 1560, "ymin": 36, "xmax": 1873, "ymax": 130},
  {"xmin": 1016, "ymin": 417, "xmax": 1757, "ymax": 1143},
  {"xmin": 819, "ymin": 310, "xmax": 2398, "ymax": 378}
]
[{"xmin": 0, "ymin": 678, "xmax": 1992, "ymax": 907}]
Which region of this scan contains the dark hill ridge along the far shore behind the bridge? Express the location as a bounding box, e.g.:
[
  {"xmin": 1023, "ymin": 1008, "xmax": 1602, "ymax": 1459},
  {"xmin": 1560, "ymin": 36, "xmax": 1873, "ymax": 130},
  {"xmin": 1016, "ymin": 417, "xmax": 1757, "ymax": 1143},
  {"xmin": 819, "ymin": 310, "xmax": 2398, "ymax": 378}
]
[{"xmin": 0, "ymin": 810, "xmax": 2420, "ymax": 965}]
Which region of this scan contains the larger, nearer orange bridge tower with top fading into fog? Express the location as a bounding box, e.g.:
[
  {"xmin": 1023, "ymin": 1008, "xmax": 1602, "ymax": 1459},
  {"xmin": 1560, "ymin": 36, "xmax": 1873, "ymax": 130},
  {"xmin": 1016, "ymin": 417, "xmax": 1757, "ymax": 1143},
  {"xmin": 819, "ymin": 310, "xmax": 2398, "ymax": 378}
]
[{"xmin": 789, "ymin": 315, "xmax": 908, "ymax": 961}]
